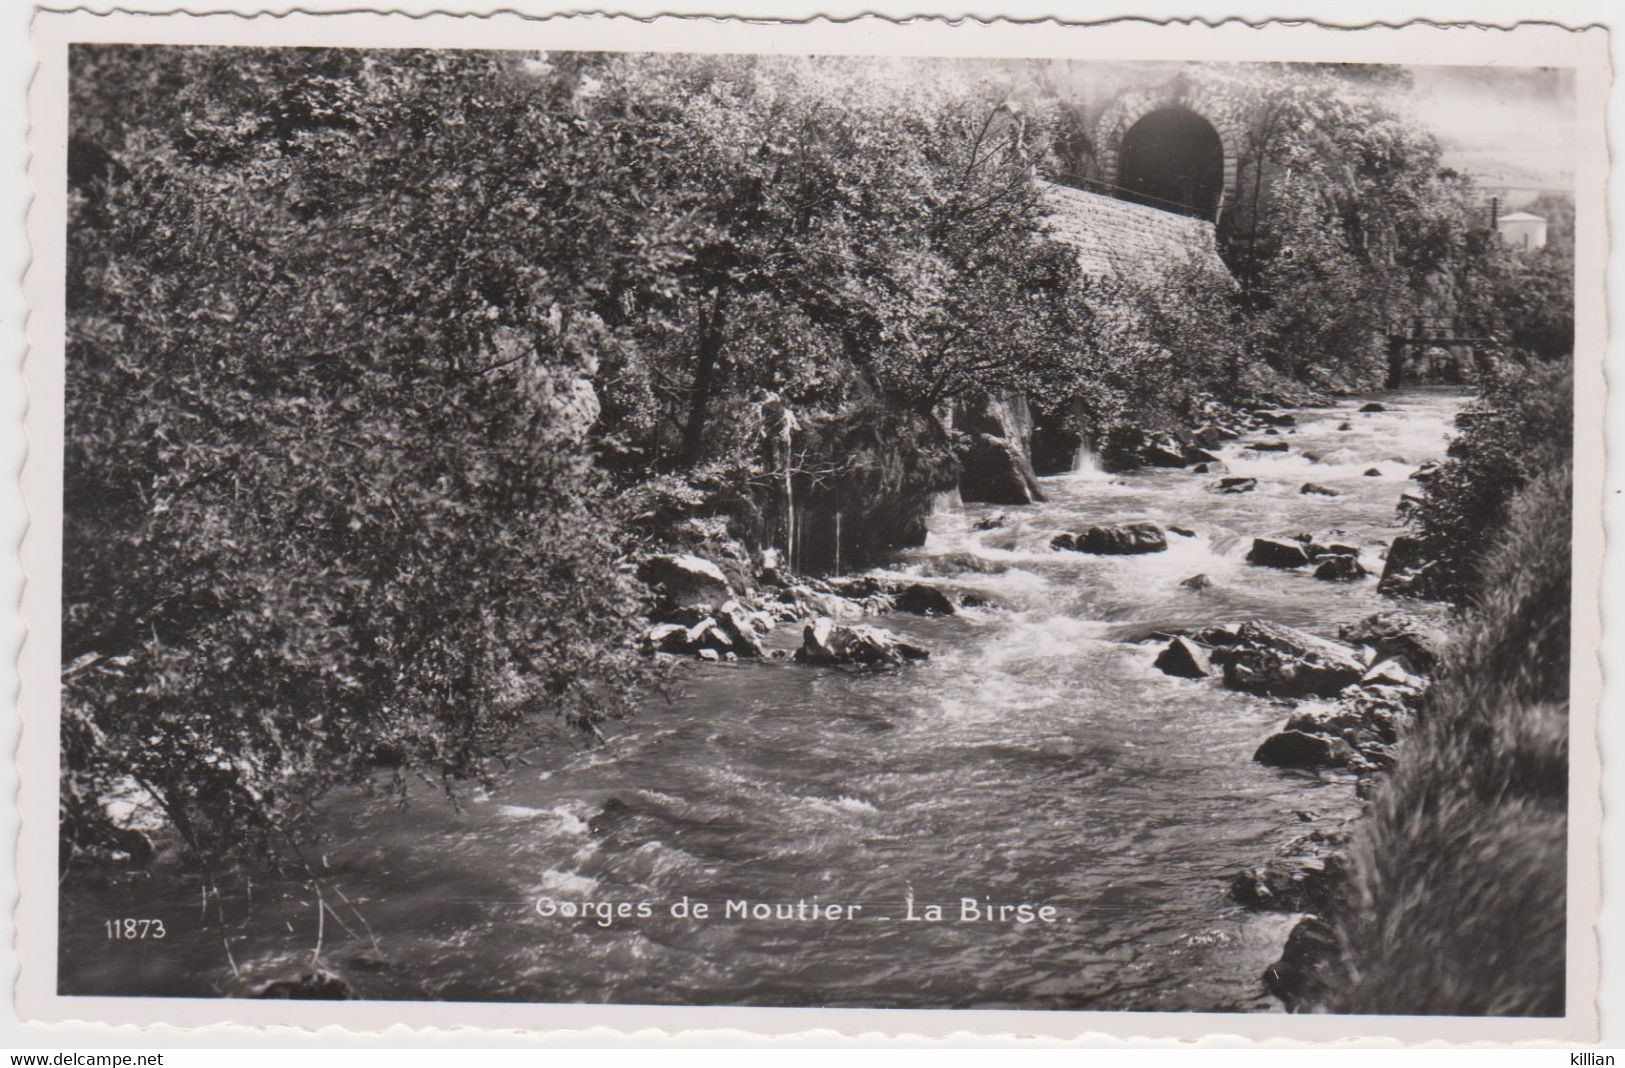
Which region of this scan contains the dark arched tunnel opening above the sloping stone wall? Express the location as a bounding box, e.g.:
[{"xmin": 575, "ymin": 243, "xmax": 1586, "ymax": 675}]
[{"xmin": 1116, "ymin": 107, "xmax": 1224, "ymax": 219}]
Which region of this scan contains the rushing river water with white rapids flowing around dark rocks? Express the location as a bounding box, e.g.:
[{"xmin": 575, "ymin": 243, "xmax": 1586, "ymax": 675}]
[{"xmin": 60, "ymin": 390, "xmax": 1464, "ymax": 1011}]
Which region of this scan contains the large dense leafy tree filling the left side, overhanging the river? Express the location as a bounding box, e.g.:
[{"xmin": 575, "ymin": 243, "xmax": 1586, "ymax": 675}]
[{"xmin": 63, "ymin": 47, "xmax": 676, "ymax": 860}]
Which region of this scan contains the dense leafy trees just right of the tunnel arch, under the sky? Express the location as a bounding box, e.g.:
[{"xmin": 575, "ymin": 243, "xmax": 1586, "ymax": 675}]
[{"xmin": 1220, "ymin": 67, "xmax": 1573, "ymax": 389}]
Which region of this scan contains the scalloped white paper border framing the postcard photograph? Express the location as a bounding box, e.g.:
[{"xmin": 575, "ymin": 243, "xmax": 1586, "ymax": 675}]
[{"xmin": 15, "ymin": 0, "xmax": 1617, "ymax": 1045}]
